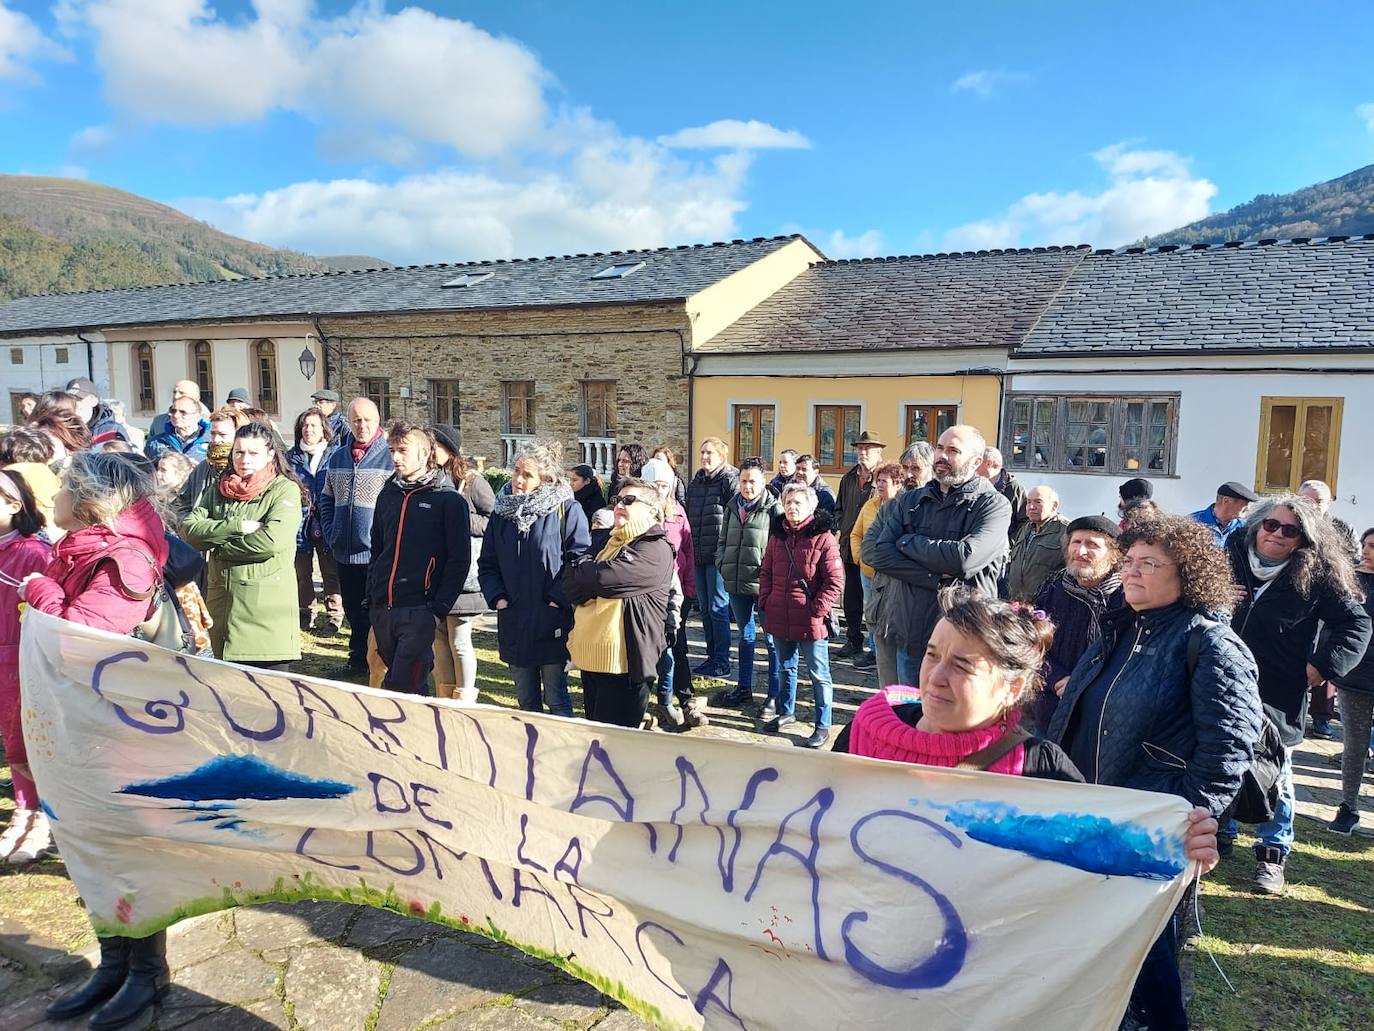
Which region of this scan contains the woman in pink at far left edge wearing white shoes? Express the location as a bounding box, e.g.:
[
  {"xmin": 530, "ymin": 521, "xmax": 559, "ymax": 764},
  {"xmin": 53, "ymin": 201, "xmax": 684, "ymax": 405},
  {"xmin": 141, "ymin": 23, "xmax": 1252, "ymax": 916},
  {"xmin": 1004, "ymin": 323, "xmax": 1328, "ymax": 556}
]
[{"xmin": 0, "ymin": 469, "xmax": 56, "ymax": 865}]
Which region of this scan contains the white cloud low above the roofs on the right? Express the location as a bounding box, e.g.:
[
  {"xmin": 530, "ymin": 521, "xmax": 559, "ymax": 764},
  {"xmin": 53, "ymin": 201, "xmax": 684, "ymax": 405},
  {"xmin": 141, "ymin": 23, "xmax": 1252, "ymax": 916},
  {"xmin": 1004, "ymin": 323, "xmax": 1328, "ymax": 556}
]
[{"xmin": 941, "ymin": 143, "xmax": 1216, "ymax": 250}]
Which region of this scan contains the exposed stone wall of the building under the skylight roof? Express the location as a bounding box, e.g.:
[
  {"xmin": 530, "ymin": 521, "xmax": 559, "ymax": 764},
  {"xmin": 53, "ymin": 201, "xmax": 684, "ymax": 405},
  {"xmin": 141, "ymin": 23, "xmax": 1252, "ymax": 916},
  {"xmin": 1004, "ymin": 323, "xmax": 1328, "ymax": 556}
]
[{"xmin": 322, "ymin": 304, "xmax": 691, "ymax": 465}]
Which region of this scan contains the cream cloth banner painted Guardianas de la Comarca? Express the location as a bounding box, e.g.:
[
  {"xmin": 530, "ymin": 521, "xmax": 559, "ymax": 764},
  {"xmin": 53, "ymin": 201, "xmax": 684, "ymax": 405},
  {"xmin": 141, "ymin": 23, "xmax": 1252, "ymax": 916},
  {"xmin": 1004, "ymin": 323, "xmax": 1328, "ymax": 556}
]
[{"xmin": 21, "ymin": 612, "xmax": 1191, "ymax": 1030}]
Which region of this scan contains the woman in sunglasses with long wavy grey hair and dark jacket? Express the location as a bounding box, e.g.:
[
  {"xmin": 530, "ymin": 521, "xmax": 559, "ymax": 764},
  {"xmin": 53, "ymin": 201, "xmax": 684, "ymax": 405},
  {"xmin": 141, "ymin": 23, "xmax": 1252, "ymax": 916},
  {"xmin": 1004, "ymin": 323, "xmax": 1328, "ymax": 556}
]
[{"xmin": 1220, "ymin": 495, "xmax": 1370, "ymax": 895}]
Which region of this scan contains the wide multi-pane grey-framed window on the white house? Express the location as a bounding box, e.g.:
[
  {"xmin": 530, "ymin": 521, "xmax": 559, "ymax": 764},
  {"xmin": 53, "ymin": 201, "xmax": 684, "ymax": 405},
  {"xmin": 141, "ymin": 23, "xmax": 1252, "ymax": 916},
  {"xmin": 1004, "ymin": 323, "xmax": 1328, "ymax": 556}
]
[{"xmin": 1002, "ymin": 393, "xmax": 1179, "ymax": 477}]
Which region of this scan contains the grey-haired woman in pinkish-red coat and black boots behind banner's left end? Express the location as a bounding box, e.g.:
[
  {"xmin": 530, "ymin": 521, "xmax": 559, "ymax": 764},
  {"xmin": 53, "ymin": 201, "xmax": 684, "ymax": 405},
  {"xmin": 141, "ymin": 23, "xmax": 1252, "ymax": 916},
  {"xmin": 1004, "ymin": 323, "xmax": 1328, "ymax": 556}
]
[{"xmin": 19, "ymin": 451, "xmax": 172, "ymax": 1028}]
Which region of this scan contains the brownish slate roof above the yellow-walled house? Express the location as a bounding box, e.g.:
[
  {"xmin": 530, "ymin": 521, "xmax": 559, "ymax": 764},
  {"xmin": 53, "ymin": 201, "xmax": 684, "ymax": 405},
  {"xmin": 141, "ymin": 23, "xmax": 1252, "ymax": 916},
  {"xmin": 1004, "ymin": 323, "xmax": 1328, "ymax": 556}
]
[{"xmin": 698, "ymin": 246, "xmax": 1090, "ymax": 353}]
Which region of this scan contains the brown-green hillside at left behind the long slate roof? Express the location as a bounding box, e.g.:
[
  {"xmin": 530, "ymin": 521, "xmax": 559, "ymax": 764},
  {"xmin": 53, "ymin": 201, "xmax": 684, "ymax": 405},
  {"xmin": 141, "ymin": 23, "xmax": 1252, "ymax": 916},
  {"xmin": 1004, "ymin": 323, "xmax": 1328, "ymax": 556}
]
[{"xmin": 0, "ymin": 175, "xmax": 386, "ymax": 301}]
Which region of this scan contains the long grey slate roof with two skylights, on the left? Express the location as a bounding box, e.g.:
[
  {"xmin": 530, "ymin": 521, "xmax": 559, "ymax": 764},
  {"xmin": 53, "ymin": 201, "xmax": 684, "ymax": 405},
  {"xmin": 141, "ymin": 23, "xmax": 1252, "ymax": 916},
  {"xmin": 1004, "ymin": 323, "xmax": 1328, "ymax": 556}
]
[{"xmin": 0, "ymin": 235, "xmax": 801, "ymax": 335}]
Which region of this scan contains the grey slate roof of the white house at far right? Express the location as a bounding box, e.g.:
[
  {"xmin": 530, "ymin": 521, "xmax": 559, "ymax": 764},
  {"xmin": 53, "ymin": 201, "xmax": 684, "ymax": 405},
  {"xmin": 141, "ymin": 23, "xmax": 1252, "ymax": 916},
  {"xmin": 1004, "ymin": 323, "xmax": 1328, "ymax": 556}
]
[{"xmin": 1013, "ymin": 234, "xmax": 1374, "ymax": 357}]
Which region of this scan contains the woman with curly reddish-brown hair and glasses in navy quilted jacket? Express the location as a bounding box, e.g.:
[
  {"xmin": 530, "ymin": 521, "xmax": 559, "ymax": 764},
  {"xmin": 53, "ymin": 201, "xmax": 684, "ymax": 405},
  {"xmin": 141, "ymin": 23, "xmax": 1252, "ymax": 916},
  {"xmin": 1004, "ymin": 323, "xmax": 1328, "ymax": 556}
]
[{"xmin": 1047, "ymin": 516, "xmax": 1260, "ymax": 1030}]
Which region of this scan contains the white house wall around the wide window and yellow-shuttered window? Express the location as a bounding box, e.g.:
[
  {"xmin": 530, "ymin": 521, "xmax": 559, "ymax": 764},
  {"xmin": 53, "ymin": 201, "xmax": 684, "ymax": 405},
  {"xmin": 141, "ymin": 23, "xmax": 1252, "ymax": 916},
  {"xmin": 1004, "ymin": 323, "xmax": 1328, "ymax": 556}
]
[{"xmin": 1007, "ymin": 363, "xmax": 1374, "ymax": 533}]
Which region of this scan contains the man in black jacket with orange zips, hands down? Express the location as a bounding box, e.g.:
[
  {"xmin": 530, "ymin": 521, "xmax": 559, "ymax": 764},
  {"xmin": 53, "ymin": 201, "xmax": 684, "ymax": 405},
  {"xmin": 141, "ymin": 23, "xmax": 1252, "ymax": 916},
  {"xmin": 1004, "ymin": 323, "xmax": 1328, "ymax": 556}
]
[{"xmin": 367, "ymin": 422, "xmax": 473, "ymax": 694}]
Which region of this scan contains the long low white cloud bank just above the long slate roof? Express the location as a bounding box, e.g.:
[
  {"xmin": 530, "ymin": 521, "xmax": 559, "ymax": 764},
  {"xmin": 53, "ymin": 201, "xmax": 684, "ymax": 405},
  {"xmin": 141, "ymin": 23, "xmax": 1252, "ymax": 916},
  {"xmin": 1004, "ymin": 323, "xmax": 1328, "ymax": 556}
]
[{"xmin": 177, "ymin": 147, "xmax": 749, "ymax": 263}]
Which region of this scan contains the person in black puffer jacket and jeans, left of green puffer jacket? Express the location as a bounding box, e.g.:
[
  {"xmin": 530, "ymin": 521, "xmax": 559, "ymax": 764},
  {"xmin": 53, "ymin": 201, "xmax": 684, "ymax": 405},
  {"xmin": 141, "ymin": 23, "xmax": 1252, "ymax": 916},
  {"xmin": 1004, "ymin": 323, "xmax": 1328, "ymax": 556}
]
[{"xmin": 687, "ymin": 437, "xmax": 739, "ymax": 676}]
